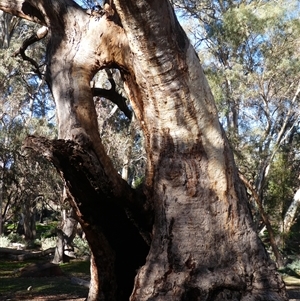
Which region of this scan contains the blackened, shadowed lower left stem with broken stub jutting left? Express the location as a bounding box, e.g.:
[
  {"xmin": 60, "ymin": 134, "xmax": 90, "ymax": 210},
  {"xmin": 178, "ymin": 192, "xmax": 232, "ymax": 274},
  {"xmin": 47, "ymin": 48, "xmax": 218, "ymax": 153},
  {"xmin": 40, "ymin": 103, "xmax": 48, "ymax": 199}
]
[{"xmin": 24, "ymin": 136, "xmax": 150, "ymax": 300}]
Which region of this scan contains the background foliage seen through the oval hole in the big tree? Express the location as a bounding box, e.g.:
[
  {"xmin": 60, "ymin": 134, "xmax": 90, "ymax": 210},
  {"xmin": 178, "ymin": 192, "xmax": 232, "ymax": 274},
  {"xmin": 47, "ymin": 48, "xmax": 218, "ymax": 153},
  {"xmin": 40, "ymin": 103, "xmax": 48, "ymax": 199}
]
[{"xmin": 94, "ymin": 70, "xmax": 146, "ymax": 186}]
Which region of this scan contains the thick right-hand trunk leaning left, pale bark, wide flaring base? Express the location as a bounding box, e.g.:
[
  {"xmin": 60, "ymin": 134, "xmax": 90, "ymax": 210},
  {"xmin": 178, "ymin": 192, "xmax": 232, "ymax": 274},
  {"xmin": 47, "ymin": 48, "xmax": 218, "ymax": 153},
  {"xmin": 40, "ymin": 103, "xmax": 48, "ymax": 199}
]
[{"xmin": 115, "ymin": 0, "xmax": 284, "ymax": 301}]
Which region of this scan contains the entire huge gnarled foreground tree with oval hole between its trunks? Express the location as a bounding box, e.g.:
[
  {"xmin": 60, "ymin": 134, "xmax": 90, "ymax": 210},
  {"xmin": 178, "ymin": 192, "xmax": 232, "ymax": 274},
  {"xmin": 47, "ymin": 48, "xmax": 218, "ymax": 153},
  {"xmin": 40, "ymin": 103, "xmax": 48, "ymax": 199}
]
[{"xmin": 0, "ymin": 0, "xmax": 286, "ymax": 301}]
